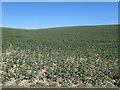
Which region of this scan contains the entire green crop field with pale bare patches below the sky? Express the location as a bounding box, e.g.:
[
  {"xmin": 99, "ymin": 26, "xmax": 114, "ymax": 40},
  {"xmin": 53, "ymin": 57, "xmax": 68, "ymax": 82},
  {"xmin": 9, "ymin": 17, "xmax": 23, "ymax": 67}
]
[{"xmin": 0, "ymin": 25, "xmax": 120, "ymax": 87}]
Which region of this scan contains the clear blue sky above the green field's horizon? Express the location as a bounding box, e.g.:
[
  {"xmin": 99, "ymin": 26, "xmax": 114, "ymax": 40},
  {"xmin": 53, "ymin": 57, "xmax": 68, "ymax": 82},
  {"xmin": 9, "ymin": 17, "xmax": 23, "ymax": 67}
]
[{"xmin": 2, "ymin": 2, "xmax": 118, "ymax": 28}]
